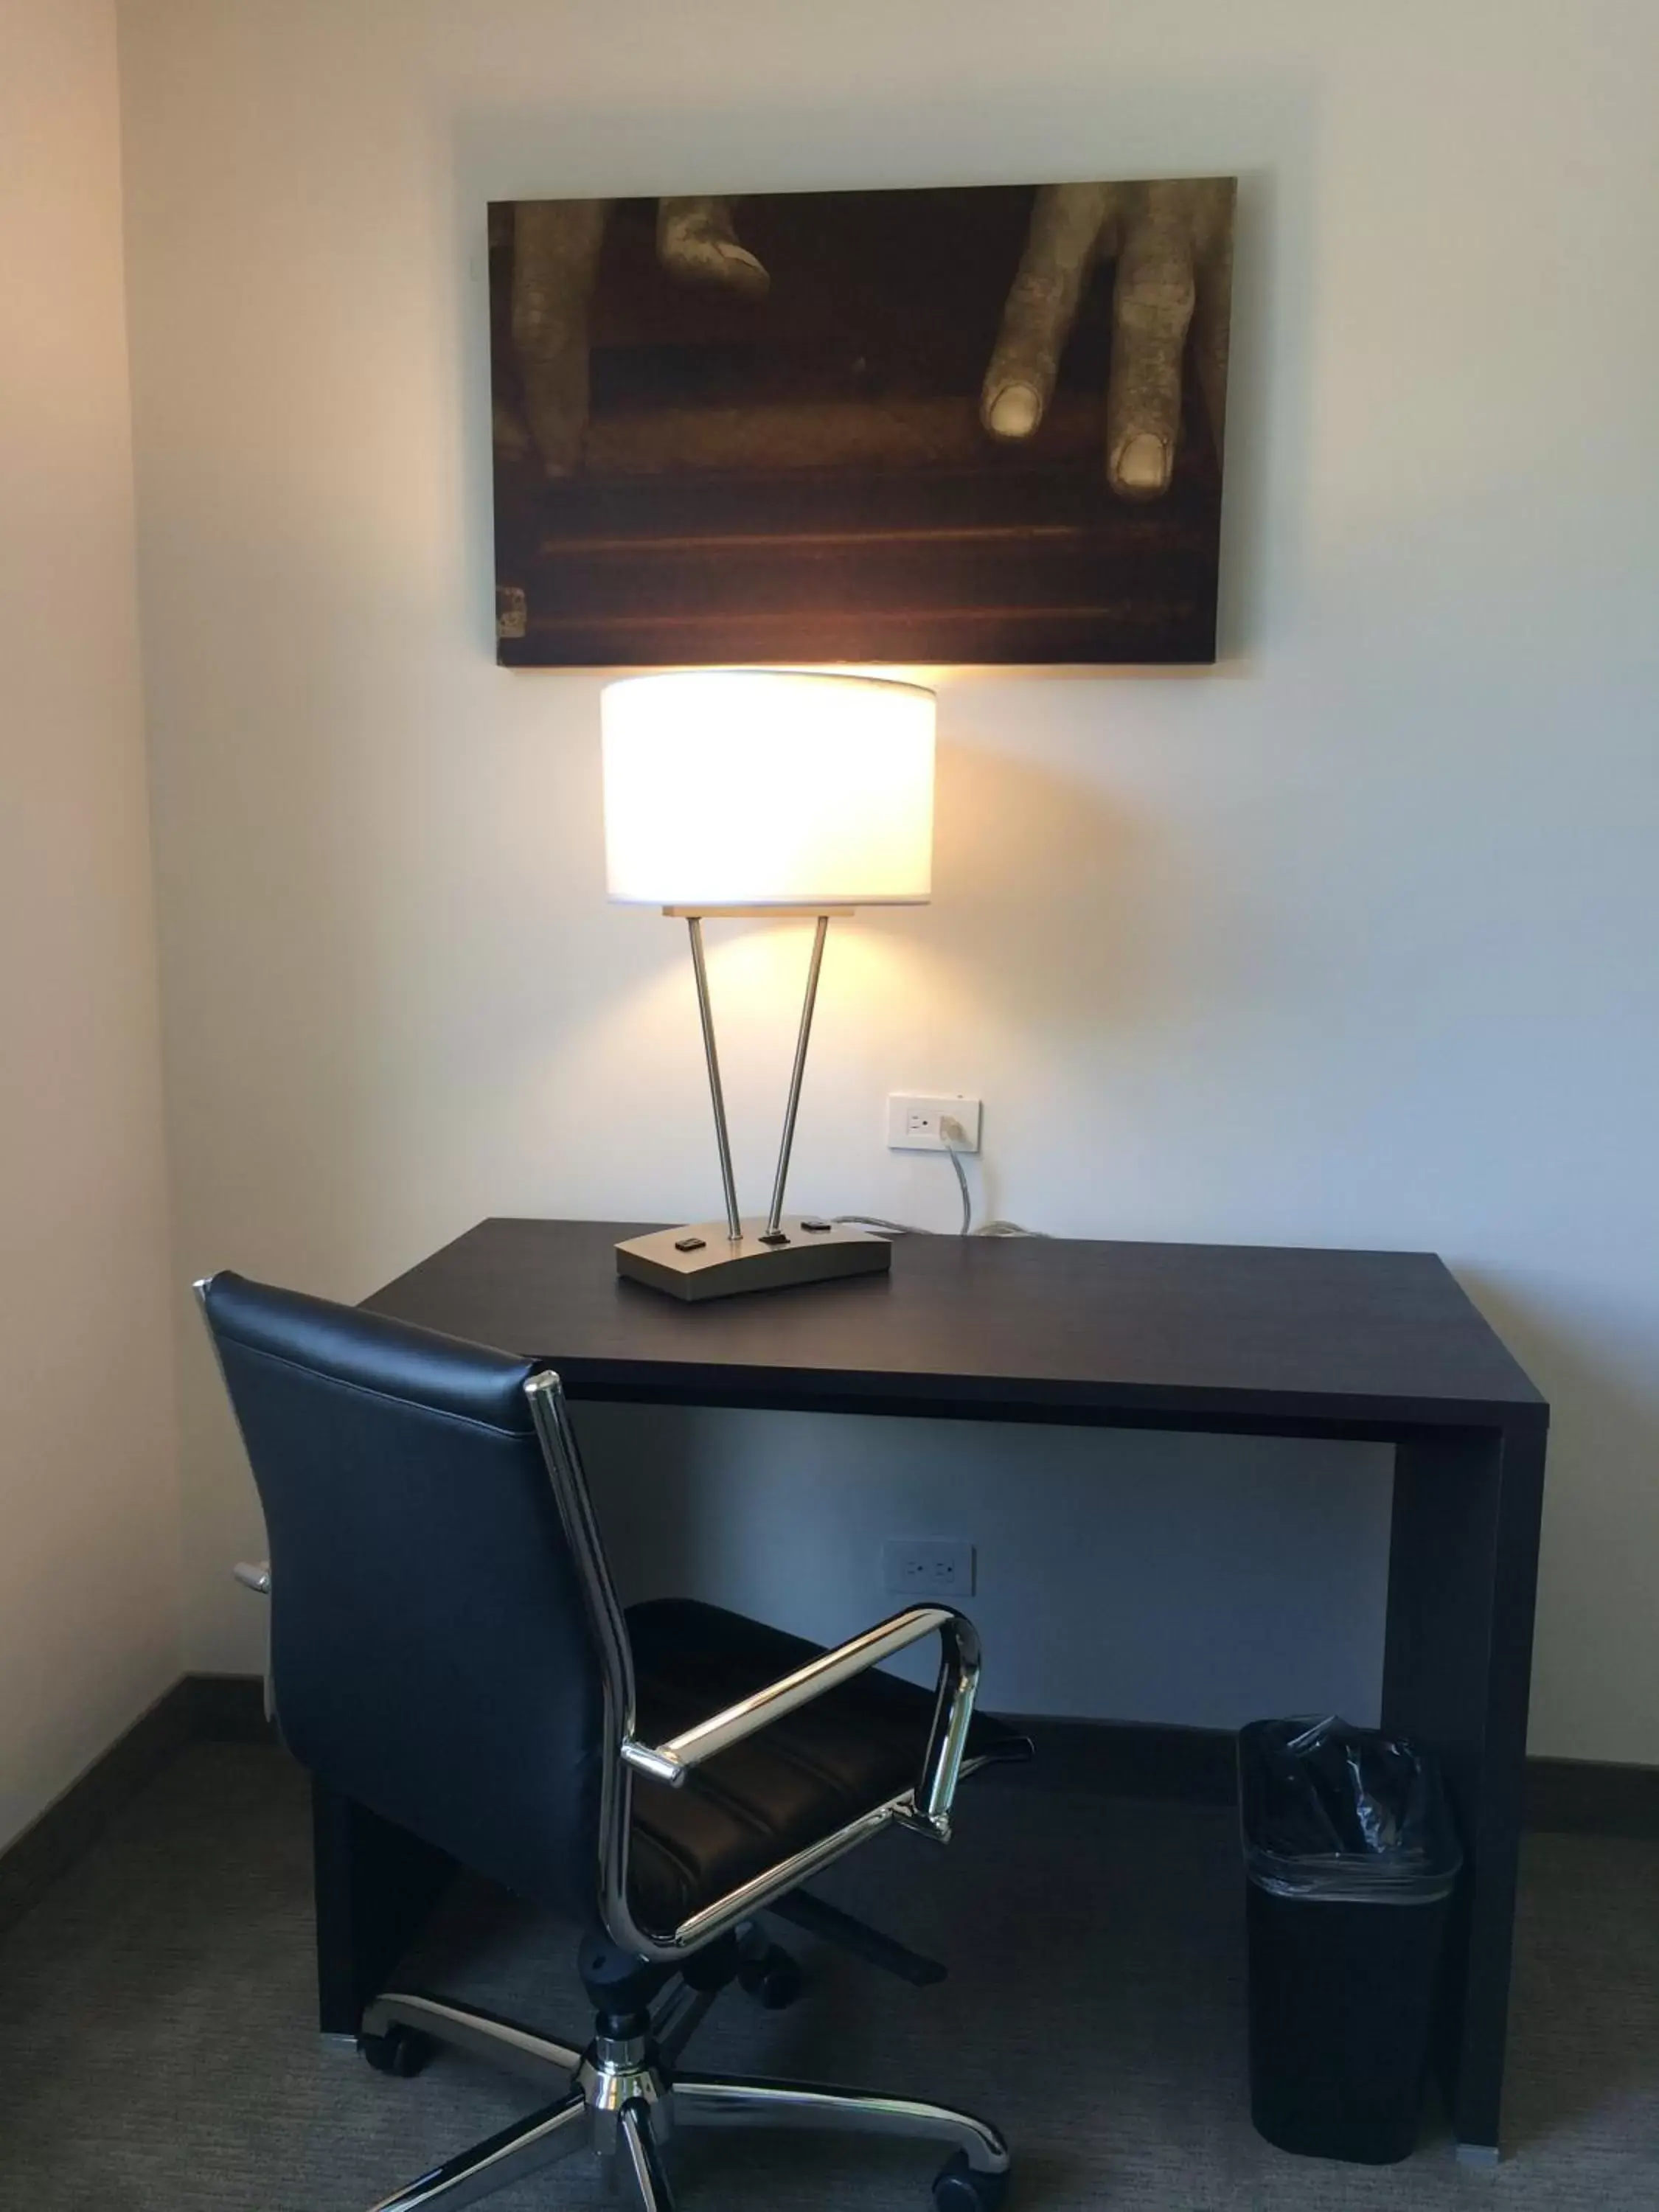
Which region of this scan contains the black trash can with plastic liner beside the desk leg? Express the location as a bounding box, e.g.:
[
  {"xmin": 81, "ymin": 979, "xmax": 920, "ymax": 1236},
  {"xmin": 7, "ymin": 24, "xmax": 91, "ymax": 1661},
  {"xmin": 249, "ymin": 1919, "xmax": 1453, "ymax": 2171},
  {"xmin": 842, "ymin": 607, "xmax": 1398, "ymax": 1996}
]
[{"xmin": 1239, "ymin": 1719, "xmax": 1462, "ymax": 2166}]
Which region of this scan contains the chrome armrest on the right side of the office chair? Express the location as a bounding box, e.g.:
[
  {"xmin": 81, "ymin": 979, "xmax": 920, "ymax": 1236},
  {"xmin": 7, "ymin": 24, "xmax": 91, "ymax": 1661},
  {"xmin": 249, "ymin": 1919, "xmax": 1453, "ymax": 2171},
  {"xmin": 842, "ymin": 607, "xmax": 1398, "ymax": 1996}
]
[{"xmin": 622, "ymin": 1606, "xmax": 980, "ymax": 1836}]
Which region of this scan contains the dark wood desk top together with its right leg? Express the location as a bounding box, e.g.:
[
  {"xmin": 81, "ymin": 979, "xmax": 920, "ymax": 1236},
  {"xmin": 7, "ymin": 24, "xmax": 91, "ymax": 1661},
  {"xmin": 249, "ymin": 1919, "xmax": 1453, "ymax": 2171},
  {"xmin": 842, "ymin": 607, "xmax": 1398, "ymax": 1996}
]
[{"xmin": 354, "ymin": 1221, "xmax": 1548, "ymax": 2154}]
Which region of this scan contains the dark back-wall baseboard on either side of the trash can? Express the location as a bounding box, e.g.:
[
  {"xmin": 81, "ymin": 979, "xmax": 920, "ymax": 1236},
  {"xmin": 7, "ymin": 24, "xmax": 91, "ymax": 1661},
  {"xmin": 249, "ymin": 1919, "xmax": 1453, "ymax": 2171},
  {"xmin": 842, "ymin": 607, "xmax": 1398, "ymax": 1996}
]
[{"xmin": 987, "ymin": 1714, "xmax": 1659, "ymax": 1840}]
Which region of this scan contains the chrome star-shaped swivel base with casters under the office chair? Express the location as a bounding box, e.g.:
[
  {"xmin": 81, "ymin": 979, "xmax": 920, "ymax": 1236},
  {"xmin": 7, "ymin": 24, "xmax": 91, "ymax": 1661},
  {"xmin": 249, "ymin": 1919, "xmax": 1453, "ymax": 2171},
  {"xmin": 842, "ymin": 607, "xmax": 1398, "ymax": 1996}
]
[{"xmin": 363, "ymin": 1947, "xmax": 1009, "ymax": 2212}]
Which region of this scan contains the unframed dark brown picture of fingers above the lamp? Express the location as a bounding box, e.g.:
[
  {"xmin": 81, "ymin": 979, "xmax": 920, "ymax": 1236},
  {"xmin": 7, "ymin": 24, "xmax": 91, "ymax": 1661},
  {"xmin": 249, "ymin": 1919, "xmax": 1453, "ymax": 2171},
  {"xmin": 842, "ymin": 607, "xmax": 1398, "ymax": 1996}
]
[{"xmin": 489, "ymin": 177, "xmax": 1234, "ymax": 668}]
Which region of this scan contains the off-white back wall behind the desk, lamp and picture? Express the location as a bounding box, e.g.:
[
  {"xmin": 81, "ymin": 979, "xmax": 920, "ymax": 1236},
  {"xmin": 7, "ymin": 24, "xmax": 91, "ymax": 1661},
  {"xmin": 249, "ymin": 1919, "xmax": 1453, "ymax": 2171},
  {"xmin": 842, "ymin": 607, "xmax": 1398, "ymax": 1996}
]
[{"xmin": 124, "ymin": 0, "xmax": 1659, "ymax": 1761}]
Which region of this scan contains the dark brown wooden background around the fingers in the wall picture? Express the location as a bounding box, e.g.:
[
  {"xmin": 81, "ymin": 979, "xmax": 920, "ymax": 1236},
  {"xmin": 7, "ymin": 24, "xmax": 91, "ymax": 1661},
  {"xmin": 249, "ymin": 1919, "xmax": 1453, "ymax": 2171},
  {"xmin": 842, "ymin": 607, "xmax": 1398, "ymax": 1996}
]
[{"xmin": 491, "ymin": 188, "xmax": 1221, "ymax": 666}]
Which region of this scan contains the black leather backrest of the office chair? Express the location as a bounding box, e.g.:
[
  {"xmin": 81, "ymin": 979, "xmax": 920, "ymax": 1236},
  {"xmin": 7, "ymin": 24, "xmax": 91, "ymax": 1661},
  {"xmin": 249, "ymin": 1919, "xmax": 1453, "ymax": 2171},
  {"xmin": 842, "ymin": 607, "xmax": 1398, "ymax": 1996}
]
[{"xmin": 201, "ymin": 1274, "xmax": 604, "ymax": 1916}]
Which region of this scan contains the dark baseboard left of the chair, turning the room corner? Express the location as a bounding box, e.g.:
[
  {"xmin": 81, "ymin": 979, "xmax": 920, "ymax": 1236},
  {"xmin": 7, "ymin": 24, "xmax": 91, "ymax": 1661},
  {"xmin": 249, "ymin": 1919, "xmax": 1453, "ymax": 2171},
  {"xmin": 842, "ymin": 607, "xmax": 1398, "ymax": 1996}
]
[{"xmin": 0, "ymin": 1674, "xmax": 270, "ymax": 1929}]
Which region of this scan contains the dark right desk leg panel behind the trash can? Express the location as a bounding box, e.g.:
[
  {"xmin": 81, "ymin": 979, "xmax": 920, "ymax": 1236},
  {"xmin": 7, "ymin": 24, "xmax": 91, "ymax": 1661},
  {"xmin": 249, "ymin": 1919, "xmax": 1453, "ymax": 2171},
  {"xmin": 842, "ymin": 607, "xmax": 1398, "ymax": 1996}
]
[{"xmin": 1382, "ymin": 1429, "xmax": 1544, "ymax": 2161}]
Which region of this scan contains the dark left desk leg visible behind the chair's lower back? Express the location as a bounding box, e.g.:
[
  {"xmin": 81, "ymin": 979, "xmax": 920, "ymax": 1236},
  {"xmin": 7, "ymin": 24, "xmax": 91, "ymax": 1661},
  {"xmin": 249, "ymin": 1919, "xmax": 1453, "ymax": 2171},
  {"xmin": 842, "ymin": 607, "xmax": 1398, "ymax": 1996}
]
[{"xmin": 312, "ymin": 1778, "xmax": 456, "ymax": 2035}]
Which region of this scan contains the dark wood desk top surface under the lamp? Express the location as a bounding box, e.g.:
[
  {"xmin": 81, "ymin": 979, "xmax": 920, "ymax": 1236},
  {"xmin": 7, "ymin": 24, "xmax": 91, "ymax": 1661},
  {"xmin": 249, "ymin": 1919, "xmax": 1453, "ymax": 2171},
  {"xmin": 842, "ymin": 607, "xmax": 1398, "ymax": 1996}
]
[{"xmin": 365, "ymin": 1219, "xmax": 1548, "ymax": 1436}]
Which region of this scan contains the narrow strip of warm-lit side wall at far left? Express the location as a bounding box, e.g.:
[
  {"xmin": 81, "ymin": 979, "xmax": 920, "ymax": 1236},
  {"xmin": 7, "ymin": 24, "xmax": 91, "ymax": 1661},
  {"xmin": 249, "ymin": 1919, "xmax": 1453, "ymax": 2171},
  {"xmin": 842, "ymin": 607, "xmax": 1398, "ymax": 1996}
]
[{"xmin": 0, "ymin": 0, "xmax": 179, "ymax": 1845}]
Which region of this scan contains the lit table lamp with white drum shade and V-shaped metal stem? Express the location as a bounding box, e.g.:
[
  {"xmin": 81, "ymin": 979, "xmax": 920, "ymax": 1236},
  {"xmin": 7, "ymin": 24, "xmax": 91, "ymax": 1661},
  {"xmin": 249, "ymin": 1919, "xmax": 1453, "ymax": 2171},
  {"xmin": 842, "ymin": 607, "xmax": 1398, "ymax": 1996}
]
[{"xmin": 599, "ymin": 668, "xmax": 933, "ymax": 1301}]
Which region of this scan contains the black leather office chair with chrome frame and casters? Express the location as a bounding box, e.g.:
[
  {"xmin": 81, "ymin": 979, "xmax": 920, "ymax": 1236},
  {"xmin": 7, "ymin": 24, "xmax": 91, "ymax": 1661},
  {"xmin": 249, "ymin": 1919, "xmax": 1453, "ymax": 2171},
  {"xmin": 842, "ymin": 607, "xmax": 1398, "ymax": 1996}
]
[{"xmin": 197, "ymin": 1274, "xmax": 1029, "ymax": 2212}]
